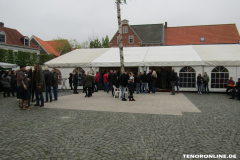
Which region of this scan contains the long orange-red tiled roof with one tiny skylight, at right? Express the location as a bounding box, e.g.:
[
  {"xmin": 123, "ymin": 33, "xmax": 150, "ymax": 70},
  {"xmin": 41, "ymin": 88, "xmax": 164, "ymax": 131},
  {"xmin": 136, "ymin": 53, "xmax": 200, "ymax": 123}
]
[{"xmin": 165, "ymin": 24, "xmax": 240, "ymax": 45}]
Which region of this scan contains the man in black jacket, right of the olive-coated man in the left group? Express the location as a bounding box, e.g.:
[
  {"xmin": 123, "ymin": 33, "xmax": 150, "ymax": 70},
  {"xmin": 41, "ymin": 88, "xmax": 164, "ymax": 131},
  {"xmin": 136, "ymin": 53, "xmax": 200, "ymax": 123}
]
[{"xmin": 44, "ymin": 67, "xmax": 53, "ymax": 103}]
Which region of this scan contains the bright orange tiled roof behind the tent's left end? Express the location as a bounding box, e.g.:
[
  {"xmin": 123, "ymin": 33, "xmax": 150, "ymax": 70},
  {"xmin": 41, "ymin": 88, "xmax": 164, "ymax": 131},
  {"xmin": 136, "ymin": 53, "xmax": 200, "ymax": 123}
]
[{"xmin": 33, "ymin": 36, "xmax": 60, "ymax": 56}]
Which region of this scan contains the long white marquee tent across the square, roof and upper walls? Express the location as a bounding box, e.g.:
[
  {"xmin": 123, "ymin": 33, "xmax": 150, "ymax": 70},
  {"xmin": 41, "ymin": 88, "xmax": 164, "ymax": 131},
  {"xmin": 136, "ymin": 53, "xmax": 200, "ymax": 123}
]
[{"xmin": 45, "ymin": 44, "xmax": 240, "ymax": 91}]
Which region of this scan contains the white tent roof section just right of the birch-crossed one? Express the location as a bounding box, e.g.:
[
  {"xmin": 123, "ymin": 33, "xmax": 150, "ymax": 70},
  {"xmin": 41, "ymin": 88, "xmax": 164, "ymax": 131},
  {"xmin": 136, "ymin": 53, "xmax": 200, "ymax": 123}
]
[{"xmin": 144, "ymin": 46, "xmax": 203, "ymax": 66}]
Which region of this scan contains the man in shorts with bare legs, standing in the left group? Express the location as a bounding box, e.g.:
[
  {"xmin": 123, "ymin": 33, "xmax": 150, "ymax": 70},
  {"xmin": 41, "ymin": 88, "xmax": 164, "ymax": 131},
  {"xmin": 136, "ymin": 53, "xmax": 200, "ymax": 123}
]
[{"xmin": 17, "ymin": 65, "xmax": 30, "ymax": 109}]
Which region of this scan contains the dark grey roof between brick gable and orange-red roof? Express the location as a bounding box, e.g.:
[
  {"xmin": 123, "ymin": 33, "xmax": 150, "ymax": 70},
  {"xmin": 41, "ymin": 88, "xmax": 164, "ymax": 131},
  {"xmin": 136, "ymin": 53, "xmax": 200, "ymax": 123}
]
[{"xmin": 130, "ymin": 24, "xmax": 164, "ymax": 44}]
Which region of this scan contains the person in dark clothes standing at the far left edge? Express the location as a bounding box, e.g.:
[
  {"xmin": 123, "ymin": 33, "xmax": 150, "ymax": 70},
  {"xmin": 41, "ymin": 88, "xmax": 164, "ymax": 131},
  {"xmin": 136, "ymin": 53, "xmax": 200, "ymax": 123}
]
[{"xmin": 2, "ymin": 71, "xmax": 11, "ymax": 97}]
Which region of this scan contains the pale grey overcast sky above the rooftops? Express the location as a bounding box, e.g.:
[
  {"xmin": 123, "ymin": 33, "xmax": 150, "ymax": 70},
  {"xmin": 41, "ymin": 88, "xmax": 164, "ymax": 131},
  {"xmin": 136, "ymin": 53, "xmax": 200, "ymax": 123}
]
[{"xmin": 0, "ymin": 0, "xmax": 240, "ymax": 42}]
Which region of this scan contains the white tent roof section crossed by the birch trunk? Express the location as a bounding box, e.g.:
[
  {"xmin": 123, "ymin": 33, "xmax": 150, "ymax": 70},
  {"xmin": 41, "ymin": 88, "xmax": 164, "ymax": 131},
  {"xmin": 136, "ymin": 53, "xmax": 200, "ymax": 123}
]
[{"xmin": 92, "ymin": 47, "xmax": 149, "ymax": 67}]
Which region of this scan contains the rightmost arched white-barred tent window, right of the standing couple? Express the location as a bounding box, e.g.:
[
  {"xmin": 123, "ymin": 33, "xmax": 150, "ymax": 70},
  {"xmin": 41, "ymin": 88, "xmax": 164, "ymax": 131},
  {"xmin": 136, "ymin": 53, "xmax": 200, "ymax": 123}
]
[{"xmin": 211, "ymin": 66, "xmax": 229, "ymax": 88}]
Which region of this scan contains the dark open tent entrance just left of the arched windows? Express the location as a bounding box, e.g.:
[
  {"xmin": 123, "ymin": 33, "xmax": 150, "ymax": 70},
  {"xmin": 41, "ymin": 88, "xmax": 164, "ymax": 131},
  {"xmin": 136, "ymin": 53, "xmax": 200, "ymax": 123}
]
[{"xmin": 149, "ymin": 66, "xmax": 172, "ymax": 91}]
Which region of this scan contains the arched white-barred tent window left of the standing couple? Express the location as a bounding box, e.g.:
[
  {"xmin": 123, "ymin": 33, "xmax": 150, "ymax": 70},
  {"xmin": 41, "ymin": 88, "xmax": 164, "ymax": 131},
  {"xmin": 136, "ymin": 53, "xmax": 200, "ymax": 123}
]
[{"xmin": 179, "ymin": 66, "xmax": 196, "ymax": 88}]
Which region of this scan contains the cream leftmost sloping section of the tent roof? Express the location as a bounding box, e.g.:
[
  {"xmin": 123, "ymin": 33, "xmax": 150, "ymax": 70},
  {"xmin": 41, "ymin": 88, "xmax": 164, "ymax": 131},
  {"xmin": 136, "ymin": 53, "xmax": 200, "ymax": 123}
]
[{"xmin": 45, "ymin": 48, "xmax": 109, "ymax": 68}]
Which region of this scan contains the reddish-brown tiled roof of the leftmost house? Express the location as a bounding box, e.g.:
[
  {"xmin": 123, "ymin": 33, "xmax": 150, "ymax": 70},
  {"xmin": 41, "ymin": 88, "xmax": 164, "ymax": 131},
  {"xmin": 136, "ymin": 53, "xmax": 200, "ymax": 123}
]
[{"xmin": 0, "ymin": 26, "xmax": 37, "ymax": 48}]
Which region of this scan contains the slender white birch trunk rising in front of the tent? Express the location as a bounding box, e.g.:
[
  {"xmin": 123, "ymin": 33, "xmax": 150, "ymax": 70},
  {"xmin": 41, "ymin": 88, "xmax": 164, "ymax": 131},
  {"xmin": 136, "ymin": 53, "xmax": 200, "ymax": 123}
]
[{"xmin": 116, "ymin": 0, "xmax": 126, "ymax": 73}]
